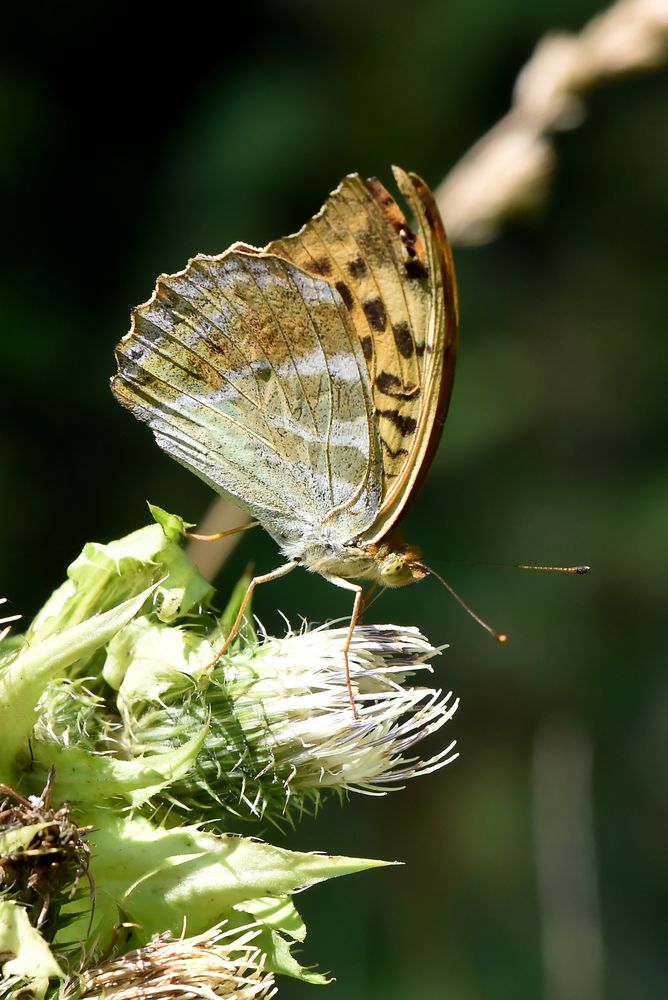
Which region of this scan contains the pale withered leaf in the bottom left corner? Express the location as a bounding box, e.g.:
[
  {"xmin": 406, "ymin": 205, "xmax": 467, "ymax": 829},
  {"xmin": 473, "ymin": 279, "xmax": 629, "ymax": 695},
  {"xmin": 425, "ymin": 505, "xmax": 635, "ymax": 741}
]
[{"xmin": 0, "ymin": 900, "xmax": 65, "ymax": 1000}]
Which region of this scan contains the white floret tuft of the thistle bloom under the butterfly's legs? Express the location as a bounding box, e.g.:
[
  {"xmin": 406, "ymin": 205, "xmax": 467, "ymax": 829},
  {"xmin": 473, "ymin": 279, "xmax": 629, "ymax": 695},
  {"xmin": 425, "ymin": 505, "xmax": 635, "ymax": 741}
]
[{"xmin": 225, "ymin": 625, "xmax": 458, "ymax": 797}]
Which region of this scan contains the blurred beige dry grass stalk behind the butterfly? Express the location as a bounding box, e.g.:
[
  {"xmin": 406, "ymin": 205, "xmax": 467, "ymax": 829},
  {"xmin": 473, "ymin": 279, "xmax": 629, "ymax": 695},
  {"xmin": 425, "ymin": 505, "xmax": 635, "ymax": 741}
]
[{"xmin": 436, "ymin": 0, "xmax": 668, "ymax": 245}]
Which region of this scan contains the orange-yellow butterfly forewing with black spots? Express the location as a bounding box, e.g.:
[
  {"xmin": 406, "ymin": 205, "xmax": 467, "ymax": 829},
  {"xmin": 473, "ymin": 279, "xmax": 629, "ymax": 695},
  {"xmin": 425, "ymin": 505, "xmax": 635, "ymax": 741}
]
[{"xmin": 265, "ymin": 167, "xmax": 458, "ymax": 542}]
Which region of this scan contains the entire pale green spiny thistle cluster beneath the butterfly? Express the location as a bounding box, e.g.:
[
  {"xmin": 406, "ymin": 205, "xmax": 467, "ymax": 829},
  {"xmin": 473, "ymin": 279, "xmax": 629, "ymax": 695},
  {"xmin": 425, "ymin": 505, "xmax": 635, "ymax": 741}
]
[{"xmin": 0, "ymin": 509, "xmax": 457, "ymax": 1000}]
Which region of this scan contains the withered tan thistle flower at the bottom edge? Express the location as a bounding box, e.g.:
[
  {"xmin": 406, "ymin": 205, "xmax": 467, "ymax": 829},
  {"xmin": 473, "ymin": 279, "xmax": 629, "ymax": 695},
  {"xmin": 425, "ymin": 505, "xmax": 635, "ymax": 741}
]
[{"xmin": 63, "ymin": 923, "xmax": 276, "ymax": 1000}]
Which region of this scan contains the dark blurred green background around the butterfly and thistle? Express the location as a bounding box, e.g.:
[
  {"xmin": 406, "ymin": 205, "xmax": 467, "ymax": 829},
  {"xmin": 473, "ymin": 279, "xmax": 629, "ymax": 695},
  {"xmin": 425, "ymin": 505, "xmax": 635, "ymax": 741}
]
[{"xmin": 0, "ymin": 0, "xmax": 668, "ymax": 1000}]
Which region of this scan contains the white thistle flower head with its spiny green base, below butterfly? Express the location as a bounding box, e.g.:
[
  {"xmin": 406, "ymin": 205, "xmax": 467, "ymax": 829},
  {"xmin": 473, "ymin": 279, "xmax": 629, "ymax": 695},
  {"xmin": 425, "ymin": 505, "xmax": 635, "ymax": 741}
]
[{"xmin": 119, "ymin": 625, "xmax": 458, "ymax": 821}]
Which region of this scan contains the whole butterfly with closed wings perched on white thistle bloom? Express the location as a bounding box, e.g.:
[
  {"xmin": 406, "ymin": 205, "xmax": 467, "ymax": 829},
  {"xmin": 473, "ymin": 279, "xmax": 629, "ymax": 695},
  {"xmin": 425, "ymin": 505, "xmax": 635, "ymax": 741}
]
[{"xmin": 111, "ymin": 167, "xmax": 459, "ymax": 709}]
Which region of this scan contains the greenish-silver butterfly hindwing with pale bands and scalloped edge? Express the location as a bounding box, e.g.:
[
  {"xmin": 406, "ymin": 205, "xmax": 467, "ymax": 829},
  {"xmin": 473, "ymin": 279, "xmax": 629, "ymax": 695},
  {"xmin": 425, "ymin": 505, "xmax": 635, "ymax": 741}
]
[{"xmin": 112, "ymin": 251, "xmax": 382, "ymax": 539}]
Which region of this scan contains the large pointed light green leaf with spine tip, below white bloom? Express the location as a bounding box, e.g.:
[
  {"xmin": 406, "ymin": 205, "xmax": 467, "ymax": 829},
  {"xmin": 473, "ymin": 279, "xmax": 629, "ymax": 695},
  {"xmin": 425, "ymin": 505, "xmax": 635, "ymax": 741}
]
[{"xmin": 59, "ymin": 810, "xmax": 392, "ymax": 948}]
